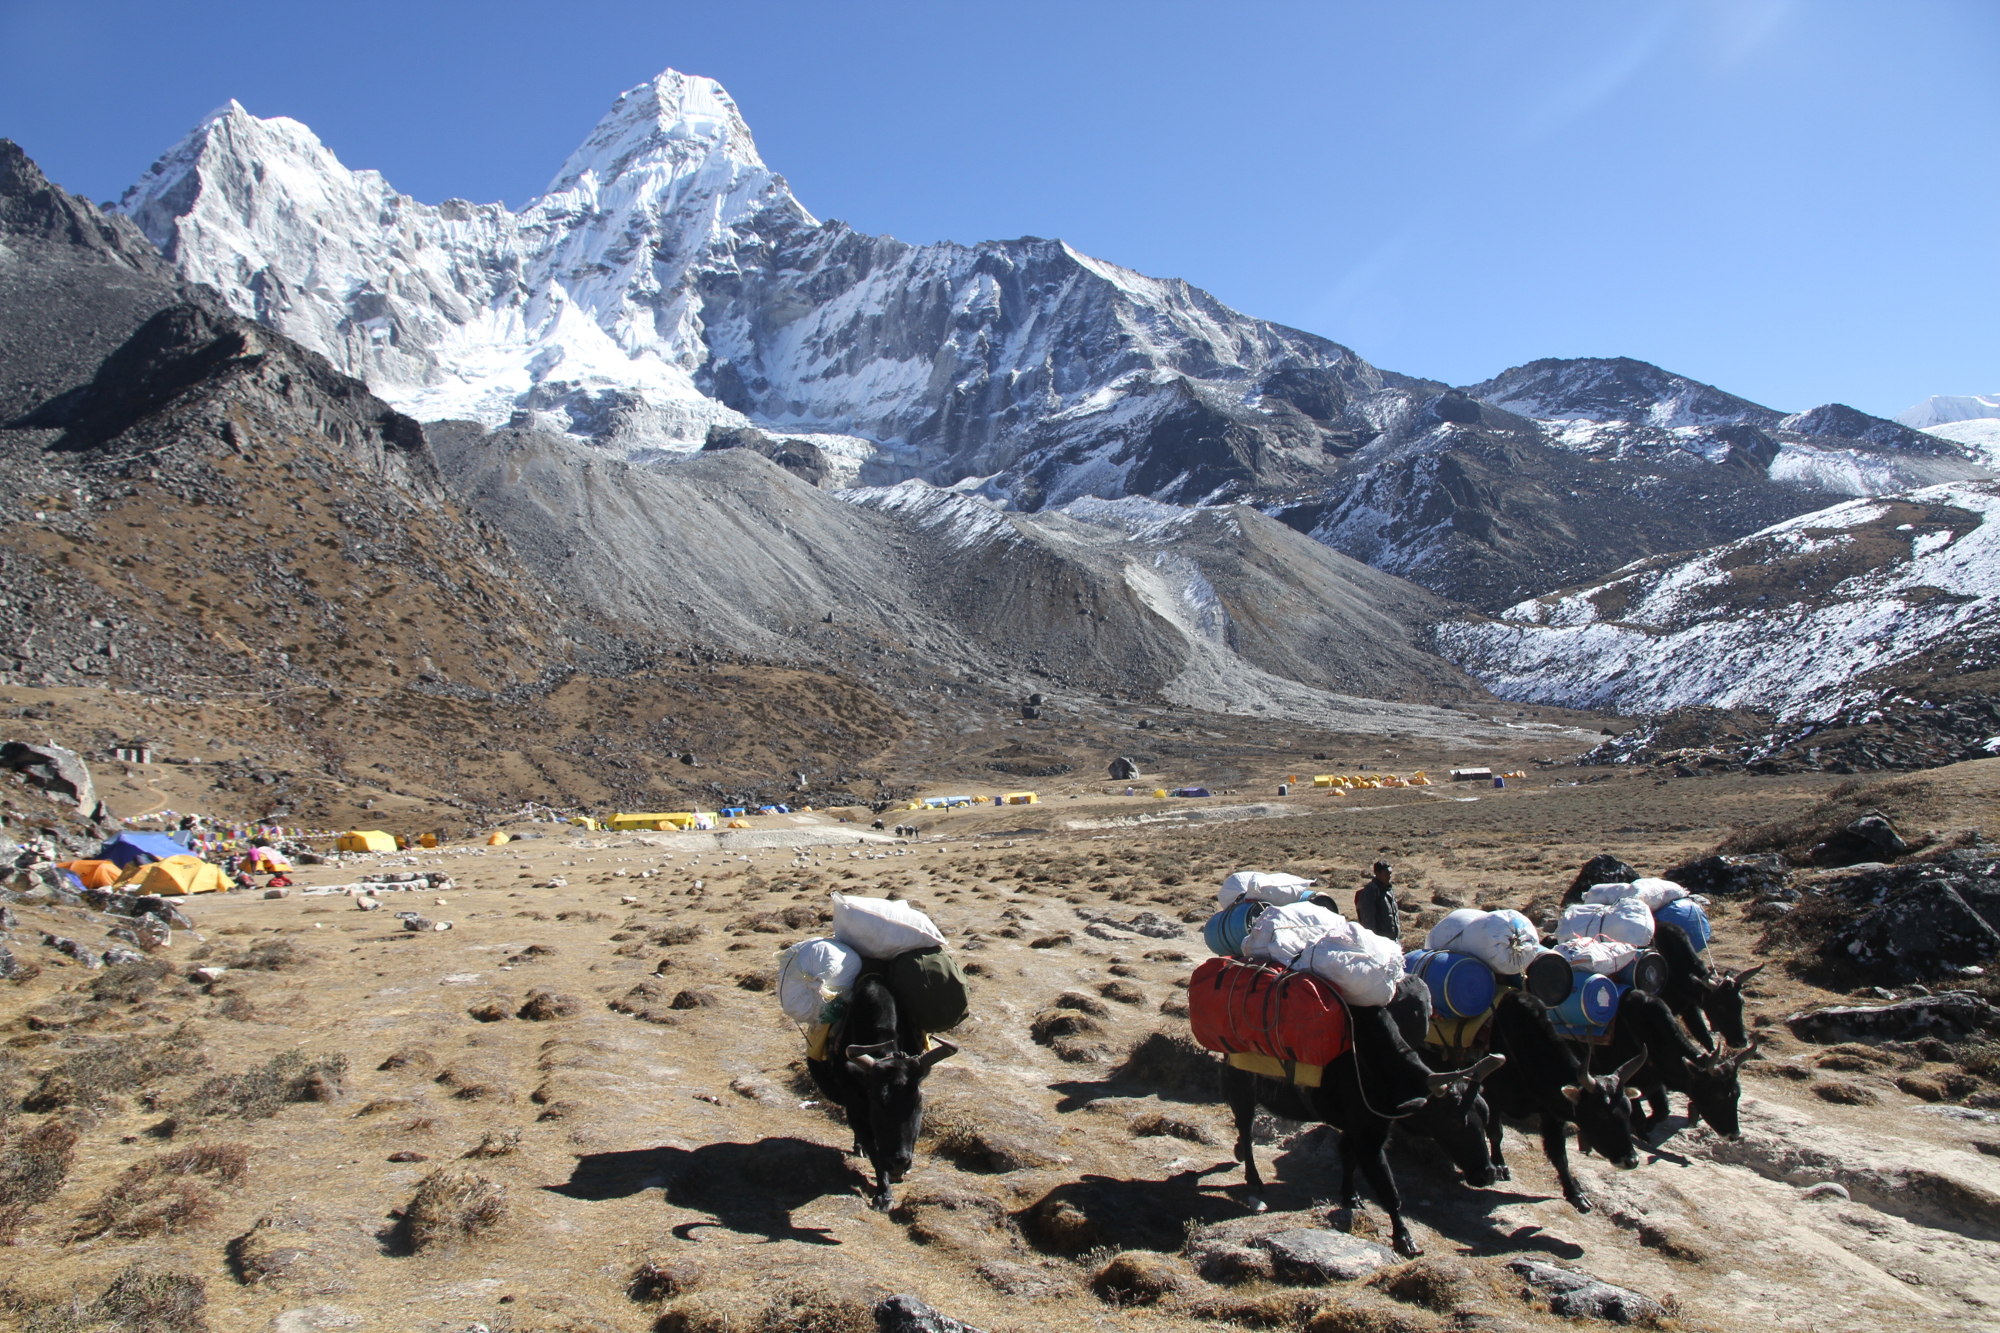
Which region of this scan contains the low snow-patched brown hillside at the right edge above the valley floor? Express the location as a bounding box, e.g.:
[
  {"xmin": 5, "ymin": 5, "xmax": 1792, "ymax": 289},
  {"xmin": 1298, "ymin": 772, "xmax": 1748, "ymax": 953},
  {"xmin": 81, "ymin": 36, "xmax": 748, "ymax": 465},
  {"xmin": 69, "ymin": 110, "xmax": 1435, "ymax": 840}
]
[{"xmin": 1436, "ymin": 480, "xmax": 2000, "ymax": 721}]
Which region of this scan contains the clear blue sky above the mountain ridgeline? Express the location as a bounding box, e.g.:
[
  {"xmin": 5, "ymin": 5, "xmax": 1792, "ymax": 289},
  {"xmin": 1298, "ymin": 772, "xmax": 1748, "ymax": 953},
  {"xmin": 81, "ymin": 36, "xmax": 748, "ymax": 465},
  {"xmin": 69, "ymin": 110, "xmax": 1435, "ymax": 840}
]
[{"xmin": 0, "ymin": 0, "xmax": 2000, "ymax": 414}]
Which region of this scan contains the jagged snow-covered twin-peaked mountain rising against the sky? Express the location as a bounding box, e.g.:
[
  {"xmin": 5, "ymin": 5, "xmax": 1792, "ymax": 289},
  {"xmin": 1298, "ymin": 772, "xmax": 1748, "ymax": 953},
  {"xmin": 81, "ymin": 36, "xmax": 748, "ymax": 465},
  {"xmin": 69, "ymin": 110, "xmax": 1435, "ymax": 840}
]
[{"xmin": 120, "ymin": 70, "xmax": 1382, "ymax": 480}]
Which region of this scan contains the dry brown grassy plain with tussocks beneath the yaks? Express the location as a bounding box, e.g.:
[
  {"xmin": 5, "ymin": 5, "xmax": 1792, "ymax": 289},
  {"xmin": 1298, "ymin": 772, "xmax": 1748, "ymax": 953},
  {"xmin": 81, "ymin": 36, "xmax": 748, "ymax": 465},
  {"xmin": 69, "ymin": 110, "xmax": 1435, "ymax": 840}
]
[{"xmin": 0, "ymin": 761, "xmax": 2000, "ymax": 1333}]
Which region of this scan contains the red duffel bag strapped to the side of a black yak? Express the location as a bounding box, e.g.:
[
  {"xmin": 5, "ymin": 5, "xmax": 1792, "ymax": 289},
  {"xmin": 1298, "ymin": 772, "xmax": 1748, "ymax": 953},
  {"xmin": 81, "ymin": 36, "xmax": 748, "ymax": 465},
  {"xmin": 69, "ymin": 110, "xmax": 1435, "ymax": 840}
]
[{"xmin": 1188, "ymin": 959, "xmax": 1348, "ymax": 1065}]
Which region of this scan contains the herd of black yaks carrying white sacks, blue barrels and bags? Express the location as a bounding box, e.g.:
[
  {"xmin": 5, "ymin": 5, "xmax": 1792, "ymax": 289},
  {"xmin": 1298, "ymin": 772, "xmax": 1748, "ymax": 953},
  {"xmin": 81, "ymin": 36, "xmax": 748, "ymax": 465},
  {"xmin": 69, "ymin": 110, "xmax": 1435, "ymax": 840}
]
[{"xmin": 780, "ymin": 875, "xmax": 1760, "ymax": 1255}]
